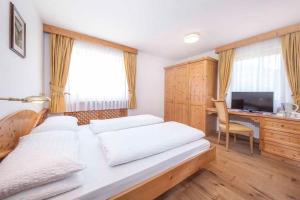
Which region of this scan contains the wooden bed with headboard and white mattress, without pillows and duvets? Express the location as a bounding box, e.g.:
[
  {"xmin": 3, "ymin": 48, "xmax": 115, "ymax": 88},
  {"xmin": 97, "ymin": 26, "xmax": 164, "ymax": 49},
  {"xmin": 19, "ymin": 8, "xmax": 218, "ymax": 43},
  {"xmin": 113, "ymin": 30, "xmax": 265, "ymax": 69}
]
[{"xmin": 0, "ymin": 110, "xmax": 216, "ymax": 200}]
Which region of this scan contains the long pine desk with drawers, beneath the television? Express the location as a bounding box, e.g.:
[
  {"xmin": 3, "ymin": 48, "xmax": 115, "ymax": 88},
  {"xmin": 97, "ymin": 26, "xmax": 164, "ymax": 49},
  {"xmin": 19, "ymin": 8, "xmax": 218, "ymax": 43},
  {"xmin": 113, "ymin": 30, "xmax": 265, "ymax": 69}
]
[{"xmin": 206, "ymin": 108, "xmax": 300, "ymax": 162}]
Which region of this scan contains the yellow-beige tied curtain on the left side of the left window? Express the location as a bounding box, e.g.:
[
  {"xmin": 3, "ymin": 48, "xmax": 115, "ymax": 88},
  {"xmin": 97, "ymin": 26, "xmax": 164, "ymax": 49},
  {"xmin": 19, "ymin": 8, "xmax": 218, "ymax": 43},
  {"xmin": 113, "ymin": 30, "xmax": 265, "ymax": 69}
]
[{"xmin": 50, "ymin": 34, "xmax": 74, "ymax": 113}]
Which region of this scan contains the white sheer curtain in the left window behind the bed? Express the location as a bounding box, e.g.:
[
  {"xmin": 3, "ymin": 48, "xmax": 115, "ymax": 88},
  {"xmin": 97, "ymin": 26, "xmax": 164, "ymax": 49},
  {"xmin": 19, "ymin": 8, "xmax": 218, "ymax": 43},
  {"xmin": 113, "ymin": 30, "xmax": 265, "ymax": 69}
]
[{"xmin": 65, "ymin": 41, "xmax": 128, "ymax": 111}]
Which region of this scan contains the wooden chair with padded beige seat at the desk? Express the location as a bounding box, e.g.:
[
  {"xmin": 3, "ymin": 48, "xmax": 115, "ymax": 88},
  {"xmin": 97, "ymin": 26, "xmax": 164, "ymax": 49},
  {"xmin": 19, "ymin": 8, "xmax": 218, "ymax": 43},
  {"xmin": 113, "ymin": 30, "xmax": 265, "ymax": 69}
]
[{"xmin": 212, "ymin": 99, "xmax": 253, "ymax": 154}]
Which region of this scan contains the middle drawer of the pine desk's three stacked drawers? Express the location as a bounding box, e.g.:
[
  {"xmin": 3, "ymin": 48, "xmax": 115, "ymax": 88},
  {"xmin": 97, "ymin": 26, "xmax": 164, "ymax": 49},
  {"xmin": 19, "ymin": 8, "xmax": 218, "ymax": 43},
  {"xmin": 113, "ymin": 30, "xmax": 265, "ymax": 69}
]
[{"xmin": 261, "ymin": 129, "xmax": 300, "ymax": 148}]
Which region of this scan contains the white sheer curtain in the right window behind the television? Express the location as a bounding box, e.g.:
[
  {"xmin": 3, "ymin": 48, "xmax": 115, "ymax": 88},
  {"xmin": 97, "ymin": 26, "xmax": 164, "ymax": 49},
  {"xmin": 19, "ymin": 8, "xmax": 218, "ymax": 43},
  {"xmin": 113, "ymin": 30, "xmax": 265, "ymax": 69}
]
[{"xmin": 227, "ymin": 39, "xmax": 292, "ymax": 112}]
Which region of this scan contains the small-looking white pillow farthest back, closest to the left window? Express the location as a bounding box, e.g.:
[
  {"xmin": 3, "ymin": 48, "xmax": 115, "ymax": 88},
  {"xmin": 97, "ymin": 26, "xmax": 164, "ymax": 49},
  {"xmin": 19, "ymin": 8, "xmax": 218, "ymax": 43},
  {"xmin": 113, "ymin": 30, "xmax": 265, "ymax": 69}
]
[{"xmin": 32, "ymin": 116, "xmax": 79, "ymax": 133}]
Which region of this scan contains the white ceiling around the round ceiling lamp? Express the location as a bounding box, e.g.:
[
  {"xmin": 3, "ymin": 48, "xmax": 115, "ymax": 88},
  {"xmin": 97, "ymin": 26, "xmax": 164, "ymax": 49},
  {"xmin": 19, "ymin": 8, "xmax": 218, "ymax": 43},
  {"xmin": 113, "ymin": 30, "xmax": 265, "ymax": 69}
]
[{"xmin": 34, "ymin": 0, "xmax": 300, "ymax": 59}]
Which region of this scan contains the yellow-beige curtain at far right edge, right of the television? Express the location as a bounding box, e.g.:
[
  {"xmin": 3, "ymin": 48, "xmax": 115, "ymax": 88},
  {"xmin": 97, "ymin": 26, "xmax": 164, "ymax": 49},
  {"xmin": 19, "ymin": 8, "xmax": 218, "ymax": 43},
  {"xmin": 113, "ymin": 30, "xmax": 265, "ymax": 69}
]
[{"xmin": 281, "ymin": 32, "xmax": 300, "ymax": 106}]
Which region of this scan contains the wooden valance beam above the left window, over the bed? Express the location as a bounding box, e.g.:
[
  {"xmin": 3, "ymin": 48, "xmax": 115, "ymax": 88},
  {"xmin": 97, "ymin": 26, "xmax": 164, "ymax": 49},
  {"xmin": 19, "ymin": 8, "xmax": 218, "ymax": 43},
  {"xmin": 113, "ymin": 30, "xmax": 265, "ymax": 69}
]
[{"xmin": 43, "ymin": 24, "xmax": 138, "ymax": 54}]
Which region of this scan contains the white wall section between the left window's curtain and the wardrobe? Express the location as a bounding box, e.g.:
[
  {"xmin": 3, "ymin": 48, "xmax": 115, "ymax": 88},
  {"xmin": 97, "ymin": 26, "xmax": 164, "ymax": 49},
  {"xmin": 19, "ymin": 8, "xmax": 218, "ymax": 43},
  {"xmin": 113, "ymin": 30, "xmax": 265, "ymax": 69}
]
[{"xmin": 128, "ymin": 52, "xmax": 174, "ymax": 117}]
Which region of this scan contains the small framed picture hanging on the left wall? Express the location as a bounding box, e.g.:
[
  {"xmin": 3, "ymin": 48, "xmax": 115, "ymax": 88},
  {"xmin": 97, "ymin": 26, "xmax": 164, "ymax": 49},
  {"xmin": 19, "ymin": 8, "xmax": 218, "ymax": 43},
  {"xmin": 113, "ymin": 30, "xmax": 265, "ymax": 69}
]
[{"xmin": 9, "ymin": 3, "xmax": 26, "ymax": 58}]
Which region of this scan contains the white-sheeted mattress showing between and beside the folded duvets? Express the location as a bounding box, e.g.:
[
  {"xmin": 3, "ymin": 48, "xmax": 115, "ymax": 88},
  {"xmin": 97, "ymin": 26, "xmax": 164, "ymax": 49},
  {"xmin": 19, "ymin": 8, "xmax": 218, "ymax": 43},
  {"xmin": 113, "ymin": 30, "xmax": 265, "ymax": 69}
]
[{"xmin": 51, "ymin": 125, "xmax": 210, "ymax": 200}]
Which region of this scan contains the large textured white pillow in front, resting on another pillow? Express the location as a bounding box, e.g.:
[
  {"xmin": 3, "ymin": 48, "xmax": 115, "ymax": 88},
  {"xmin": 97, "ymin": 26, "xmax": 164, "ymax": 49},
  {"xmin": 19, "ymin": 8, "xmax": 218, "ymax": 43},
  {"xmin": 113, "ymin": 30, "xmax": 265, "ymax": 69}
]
[{"xmin": 0, "ymin": 131, "xmax": 84, "ymax": 199}]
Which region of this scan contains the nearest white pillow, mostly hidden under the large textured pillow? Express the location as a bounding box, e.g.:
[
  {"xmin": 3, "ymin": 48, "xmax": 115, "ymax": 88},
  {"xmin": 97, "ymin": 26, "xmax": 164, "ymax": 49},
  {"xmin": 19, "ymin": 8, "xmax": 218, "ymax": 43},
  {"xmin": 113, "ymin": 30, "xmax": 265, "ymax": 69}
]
[{"xmin": 4, "ymin": 173, "xmax": 81, "ymax": 200}]
